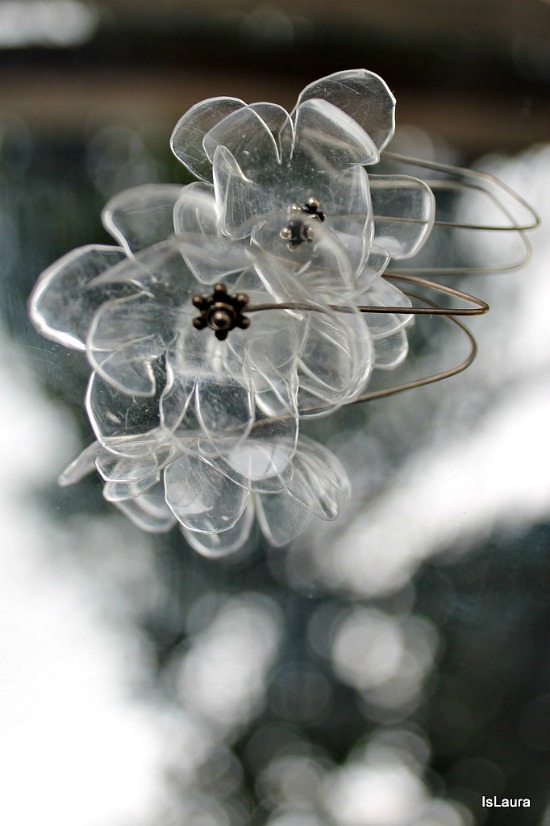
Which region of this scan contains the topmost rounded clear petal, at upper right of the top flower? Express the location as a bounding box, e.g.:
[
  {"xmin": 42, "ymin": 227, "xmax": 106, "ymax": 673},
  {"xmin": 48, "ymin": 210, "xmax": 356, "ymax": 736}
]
[{"xmin": 298, "ymin": 69, "xmax": 395, "ymax": 150}]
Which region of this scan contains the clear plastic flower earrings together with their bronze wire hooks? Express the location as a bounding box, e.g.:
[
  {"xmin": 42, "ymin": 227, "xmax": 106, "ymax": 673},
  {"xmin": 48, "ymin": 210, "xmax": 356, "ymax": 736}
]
[{"xmin": 29, "ymin": 69, "xmax": 538, "ymax": 556}]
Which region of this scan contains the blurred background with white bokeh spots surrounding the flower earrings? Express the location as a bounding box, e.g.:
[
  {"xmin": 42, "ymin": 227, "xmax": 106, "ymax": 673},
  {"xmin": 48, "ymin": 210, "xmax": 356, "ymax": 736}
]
[{"xmin": 0, "ymin": 0, "xmax": 550, "ymax": 826}]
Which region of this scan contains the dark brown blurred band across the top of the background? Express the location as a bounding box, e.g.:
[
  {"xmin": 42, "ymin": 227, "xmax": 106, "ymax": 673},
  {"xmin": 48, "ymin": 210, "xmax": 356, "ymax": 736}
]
[{"xmin": 0, "ymin": 0, "xmax": 550, "ymax": 153}]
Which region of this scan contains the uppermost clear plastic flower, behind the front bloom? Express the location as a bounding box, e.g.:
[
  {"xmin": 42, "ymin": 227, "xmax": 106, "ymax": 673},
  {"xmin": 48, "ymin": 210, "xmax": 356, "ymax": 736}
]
[{"xmin": 171, "ymin": 69, "xmax": 435, "ymax": 282}]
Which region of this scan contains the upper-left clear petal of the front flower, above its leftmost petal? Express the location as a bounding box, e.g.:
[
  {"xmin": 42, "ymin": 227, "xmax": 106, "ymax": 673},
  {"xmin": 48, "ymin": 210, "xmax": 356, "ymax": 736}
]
[{"xmin": 101, "ymin": 184, "xmax": 182, "ymax": 255}]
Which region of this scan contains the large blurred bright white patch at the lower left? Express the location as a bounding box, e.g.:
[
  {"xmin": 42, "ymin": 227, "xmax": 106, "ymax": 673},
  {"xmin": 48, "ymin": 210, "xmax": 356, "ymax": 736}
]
[{"xmin": 0, "ymin": 334, "xmax": 175, "ymax": 826}]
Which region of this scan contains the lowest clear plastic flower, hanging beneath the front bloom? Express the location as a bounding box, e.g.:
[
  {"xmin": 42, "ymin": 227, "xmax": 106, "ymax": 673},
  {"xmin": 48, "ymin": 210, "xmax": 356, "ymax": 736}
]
[{"xmin": 60, "ymin": 428, "xmax": 349, "ymax": 556}]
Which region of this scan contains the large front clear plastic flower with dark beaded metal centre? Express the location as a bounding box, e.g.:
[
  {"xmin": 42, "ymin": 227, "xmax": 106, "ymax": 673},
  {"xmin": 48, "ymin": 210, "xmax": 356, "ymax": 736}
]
[{"xmin": 30, "ymin": 185, "xmax": 396, "ymax": 464}]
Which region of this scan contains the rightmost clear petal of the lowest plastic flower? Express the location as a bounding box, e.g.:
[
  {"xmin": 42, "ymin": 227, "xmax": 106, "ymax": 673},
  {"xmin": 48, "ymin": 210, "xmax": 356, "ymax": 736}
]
[{"xmin": 288, "ymin": 437, "xmax": 350, "ymax": 519}]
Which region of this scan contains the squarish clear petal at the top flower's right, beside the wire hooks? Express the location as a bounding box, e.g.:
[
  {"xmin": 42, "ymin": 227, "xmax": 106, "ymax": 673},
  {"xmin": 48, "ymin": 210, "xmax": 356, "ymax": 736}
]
[{"xmin": 369, "ymin": 175, "xmax": 435, "ymax": 258}]
